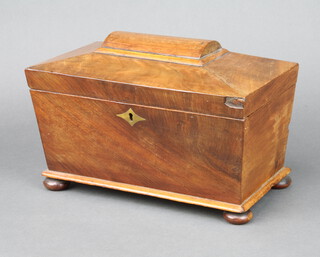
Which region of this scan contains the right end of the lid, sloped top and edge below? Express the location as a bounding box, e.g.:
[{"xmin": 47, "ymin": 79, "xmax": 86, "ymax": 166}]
[{"xmin": 206, "ymin": 52, "xmax": 299, "ymax": 116}]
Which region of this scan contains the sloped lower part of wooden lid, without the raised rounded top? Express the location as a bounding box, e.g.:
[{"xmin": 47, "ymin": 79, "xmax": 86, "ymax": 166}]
[{"xmin": 26, "ymin": 42, "xmax": 298, "ymax": 118}]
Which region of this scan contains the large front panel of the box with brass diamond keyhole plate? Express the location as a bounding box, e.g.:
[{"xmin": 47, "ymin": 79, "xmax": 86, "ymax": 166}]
[{"xmin": 31, "ymin": 91, "xmax": 243, "ymax": 204}]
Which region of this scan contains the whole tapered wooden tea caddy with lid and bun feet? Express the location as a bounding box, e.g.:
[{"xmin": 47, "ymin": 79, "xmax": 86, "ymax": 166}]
[{"xmin": 25, "ymin": 32, "xmax": 298, "ymax": 224}]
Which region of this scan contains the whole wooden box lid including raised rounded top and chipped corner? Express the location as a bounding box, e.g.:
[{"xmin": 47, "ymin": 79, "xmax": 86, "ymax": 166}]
[{"xmin": 26, "ymin": 32, "xmax": 298, "ymax": 118}]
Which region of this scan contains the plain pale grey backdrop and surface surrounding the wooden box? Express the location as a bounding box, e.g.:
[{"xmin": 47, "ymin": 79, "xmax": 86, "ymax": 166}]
[{"xmin": 0, "ymin": 0, "xmax": 320, "ymax": 257}]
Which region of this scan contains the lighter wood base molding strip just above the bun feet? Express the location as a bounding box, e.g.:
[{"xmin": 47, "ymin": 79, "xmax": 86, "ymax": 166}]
[{"xmin": 42, "ymin": 167, "xmax": 291, "ymax": 213}]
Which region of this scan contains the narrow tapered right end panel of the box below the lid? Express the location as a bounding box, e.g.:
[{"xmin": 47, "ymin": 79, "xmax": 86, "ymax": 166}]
[{"xmin": 242, "ymin": 86, "xmax": 295, "ymax": 200}]
